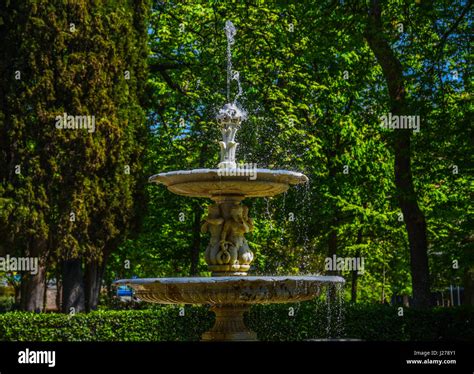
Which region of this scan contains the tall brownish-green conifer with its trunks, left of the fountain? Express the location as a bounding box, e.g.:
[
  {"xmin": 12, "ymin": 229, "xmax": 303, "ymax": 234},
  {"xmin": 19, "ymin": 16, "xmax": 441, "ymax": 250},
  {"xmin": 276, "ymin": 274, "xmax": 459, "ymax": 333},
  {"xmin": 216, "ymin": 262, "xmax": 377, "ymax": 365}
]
[{"xmin": 0, "ymin": 1, "xmax": 149, "ymax": 312}]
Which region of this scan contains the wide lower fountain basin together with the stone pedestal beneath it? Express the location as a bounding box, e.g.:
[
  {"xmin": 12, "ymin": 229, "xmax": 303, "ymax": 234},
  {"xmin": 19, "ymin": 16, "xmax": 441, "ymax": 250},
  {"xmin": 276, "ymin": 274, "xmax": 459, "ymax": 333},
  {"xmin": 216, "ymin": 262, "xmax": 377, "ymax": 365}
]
[{"xmin": 115, "ymin": 276, "xmax": 344, "ymax": 341}]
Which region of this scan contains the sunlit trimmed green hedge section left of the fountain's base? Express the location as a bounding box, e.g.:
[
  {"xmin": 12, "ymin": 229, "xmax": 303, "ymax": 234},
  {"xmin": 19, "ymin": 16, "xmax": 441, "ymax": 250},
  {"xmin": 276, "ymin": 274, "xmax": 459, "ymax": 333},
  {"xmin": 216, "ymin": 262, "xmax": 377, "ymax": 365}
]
[{"xmin": 0, "ymin": 307, "xmax": 212, "ymax": 341}]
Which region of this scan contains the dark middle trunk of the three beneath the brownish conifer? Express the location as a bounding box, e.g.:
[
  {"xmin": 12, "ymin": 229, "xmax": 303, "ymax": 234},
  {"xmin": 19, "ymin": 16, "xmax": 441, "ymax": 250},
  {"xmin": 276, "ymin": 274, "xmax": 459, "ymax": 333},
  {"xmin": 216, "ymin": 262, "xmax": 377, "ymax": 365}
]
[{"xmin": 62, "ymin": 258, "xmax": 85, "ymax": 313}]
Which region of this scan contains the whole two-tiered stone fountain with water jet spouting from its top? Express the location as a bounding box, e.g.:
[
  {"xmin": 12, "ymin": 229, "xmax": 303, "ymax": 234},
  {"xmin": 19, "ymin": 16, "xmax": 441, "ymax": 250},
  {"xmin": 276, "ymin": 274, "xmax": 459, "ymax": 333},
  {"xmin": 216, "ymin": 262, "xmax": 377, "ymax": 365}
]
[{"xmin": 116, "ymin": 21, "xmax": 344, "ymax": 341}]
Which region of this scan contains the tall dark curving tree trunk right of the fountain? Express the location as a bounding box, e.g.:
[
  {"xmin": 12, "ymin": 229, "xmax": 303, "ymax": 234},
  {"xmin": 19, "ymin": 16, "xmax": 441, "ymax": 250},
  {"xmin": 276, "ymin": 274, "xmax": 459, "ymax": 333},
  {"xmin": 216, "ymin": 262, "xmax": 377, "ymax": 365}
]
[{"xmin": 365, "ymin": 0, "xmax": 431, "ymax": 308}]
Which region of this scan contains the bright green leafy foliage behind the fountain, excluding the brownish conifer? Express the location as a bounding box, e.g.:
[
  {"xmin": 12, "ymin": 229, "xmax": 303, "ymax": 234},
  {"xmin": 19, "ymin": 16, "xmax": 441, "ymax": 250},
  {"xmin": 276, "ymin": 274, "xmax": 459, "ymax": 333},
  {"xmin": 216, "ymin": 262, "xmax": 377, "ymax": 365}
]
[{"xmin": 109, "ymin": 1, "xmax": 474, "ymax": 301}]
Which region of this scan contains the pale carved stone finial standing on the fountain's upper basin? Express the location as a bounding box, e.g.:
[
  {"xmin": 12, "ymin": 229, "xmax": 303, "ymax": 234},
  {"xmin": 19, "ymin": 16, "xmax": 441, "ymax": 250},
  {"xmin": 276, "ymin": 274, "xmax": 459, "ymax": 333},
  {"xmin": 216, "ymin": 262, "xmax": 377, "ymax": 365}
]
[{"xmin": 216, "ymin": 103, "xmax": 246, "ymax": 169}]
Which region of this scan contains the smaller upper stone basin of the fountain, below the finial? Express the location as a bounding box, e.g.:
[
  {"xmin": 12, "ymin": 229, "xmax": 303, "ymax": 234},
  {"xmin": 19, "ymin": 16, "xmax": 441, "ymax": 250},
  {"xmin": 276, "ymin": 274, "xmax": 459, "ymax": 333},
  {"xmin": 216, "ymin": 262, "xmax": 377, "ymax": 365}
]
[{"xmin": 149, "ymin": 168, "xmax": 308, "ymax": 198}]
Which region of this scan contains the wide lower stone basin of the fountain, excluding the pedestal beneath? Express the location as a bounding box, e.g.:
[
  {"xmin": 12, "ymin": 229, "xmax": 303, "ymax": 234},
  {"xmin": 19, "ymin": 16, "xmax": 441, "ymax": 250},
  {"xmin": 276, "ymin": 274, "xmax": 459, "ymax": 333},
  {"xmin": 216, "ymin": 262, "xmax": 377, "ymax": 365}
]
[{"xmin": 115, "ymin": 276, "xmax": 345, "ymax": 305}]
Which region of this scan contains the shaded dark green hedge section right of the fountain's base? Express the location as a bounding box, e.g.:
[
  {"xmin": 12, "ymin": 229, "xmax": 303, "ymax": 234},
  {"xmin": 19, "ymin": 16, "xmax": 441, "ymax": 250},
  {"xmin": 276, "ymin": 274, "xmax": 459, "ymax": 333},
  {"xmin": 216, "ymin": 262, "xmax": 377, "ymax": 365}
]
[{"xmin": 247, "ymin": 301, "xmax": 474, "ymax": 341}]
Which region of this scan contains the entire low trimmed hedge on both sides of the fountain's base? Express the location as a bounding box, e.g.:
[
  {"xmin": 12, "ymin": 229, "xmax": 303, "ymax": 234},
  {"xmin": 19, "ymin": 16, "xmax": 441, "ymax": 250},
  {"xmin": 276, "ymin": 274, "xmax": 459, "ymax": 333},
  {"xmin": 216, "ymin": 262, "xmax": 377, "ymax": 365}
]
[{"xmin": 0, "ymin": 301, "xmax": 474, "ymax": 341}]
